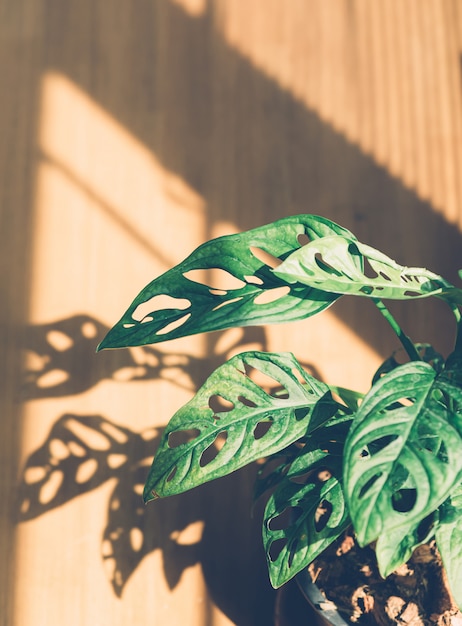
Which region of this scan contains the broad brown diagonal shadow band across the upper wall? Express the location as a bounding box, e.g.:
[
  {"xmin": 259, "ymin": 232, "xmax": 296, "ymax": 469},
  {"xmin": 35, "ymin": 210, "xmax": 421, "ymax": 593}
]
[{"xmin": 40, "ymin": 0, "xmax": 462, "ymax": 355}]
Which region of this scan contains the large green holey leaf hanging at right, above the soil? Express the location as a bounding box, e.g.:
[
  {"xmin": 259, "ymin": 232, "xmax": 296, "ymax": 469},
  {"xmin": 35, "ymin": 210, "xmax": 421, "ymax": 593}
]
[{"xmin": 344, "ymin": 355, "xmax": 462, "ymax": 545}]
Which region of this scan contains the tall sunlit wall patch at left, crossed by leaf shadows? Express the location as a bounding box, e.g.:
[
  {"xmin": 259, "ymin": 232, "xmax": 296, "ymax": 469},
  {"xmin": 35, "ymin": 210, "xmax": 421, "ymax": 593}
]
[{"xmin": 15, "ymin": 72, "xmax": 235, "ymax": 624}]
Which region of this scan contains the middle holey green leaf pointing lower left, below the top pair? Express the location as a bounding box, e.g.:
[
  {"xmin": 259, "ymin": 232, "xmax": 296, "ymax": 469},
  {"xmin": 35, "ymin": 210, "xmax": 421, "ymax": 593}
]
[{"xmin": 144, "ymin": 352, "xmax": 338, "ymax": 501}]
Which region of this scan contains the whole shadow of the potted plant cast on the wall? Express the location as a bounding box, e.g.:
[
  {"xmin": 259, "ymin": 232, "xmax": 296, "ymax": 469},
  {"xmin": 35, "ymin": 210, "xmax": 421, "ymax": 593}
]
[{"xmin": 17, "ymin": 314, "xmax": 317, "ymax": 626}]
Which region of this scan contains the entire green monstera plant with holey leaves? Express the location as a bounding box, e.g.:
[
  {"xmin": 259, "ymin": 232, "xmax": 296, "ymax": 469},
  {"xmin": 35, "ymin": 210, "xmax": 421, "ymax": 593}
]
[{"xmin": 98, "ymin": 215, "xmax": 462, "ymax": 606}]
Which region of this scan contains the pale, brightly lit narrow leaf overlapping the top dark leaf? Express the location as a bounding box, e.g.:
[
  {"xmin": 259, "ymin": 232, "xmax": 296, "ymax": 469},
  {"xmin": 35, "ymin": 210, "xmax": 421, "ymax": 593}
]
[{"xmin": 273, "ymin": 235, "xmax": 451, "ymax": 299}]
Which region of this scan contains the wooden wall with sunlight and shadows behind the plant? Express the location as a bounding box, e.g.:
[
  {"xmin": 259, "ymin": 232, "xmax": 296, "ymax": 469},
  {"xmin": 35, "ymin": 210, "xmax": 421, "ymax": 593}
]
[{"xmin": 0, "ymin": 0, "xmax": 462, "ymax": 626}]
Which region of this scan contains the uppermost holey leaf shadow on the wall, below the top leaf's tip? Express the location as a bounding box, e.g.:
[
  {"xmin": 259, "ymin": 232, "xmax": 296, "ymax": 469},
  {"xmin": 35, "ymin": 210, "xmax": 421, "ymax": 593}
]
[{"xmin": 21, "ymin": 314, "xmax": 266, "ymax": 400}]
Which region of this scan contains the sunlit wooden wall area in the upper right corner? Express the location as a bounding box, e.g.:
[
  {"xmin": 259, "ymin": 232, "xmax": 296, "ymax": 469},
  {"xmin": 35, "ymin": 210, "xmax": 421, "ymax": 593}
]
[{"xmin": 216, "ymin": 0, "xmax": 462, "ymax": 227}]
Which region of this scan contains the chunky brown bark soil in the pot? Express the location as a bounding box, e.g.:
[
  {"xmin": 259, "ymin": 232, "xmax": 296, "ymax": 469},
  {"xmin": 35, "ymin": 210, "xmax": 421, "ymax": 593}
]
[{"xmin": 309, "ymin": 533, "xmax": 462, "ymax": 626}]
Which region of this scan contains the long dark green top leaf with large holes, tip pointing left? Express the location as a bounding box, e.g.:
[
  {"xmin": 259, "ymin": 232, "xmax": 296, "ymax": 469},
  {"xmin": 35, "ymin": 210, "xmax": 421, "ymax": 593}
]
[{"xmin": 98, "ymin": 215, "xmax": 354, "ymax": 350}]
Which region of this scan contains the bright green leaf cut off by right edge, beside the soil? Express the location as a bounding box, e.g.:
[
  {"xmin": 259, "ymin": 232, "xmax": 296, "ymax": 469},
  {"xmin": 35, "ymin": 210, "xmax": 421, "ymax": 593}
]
[{"xmin": 435, "ymin": 483, "xmax": 462, "ymax": 611}]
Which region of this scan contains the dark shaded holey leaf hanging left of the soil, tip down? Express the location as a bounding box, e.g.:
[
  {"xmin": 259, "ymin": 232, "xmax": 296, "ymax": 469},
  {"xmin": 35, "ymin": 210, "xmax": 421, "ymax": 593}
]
[{"xmin": 263, "ymin": 434, "xmax": 350, "ymax": 588}]
